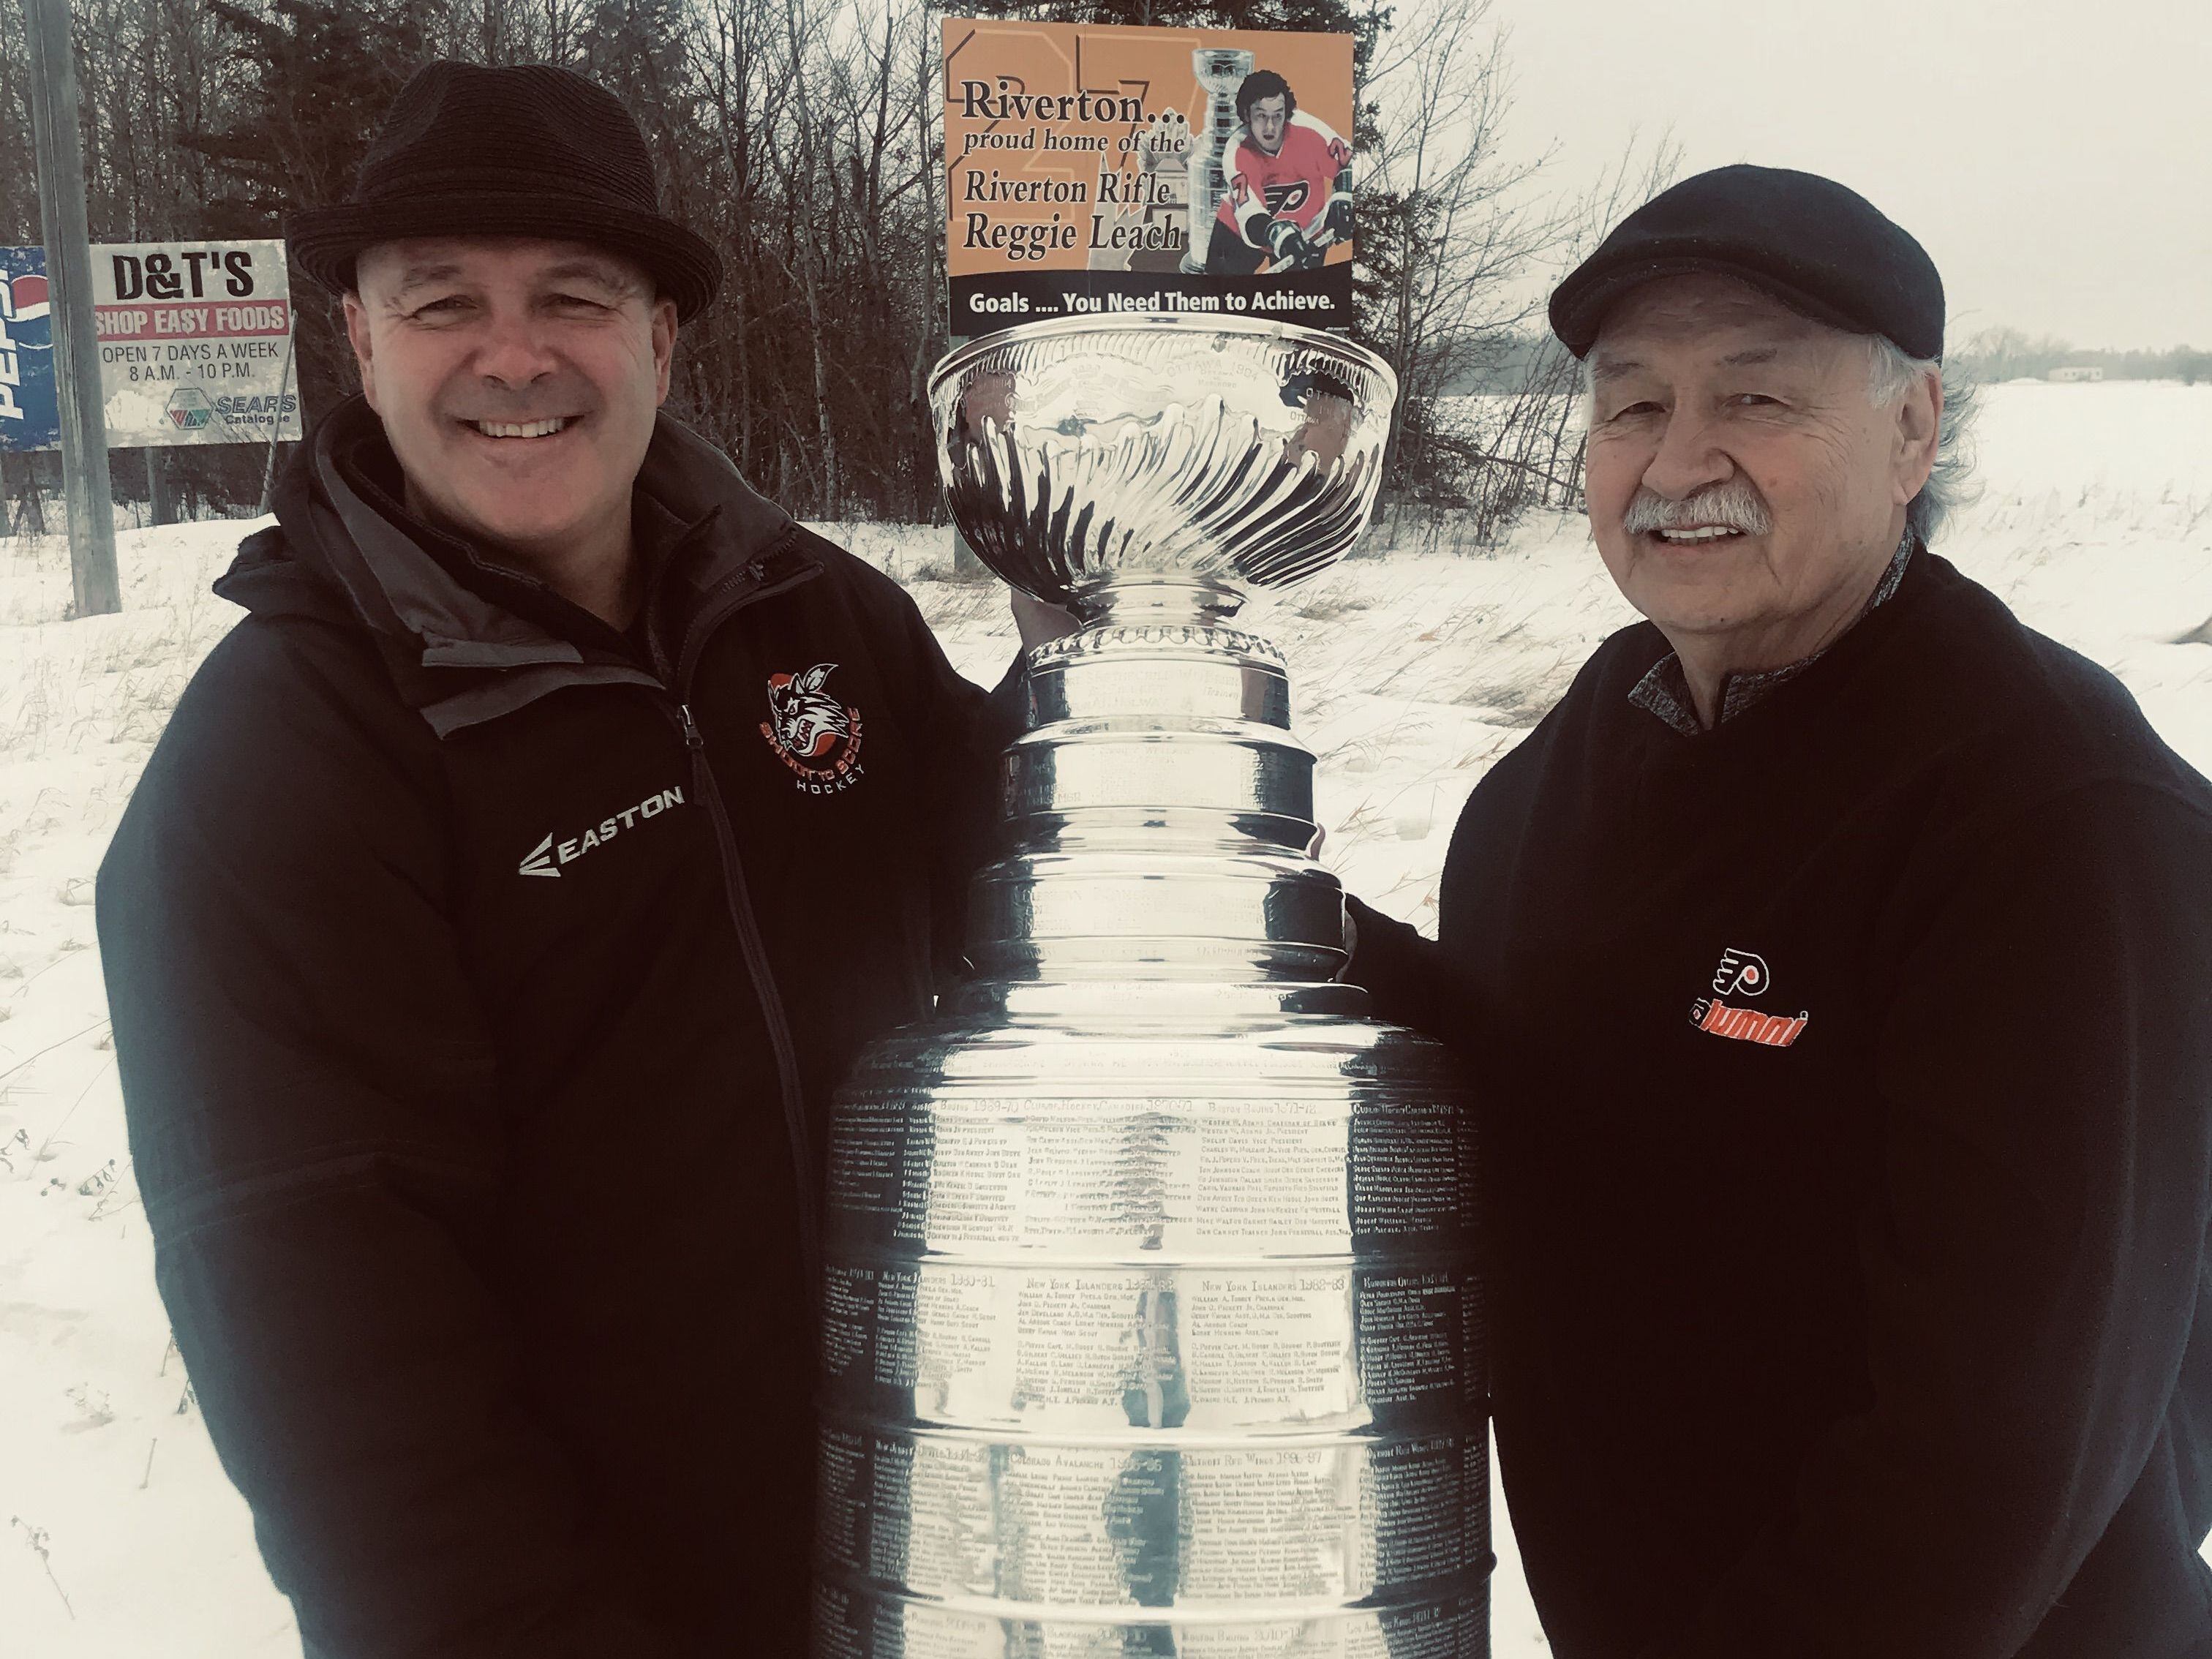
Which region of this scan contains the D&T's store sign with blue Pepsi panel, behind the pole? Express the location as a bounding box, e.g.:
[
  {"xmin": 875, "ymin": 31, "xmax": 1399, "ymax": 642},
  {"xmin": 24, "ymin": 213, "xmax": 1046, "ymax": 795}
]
[{"xmin": 0, "ymin": 241, "xmax": 301, "ymax": 449}]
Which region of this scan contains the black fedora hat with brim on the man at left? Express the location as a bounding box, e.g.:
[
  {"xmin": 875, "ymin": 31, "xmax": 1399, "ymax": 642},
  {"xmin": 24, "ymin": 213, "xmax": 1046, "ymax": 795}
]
[{"xmin": 285, "ymin": 62, "xmax": 721, "ymax": 320}]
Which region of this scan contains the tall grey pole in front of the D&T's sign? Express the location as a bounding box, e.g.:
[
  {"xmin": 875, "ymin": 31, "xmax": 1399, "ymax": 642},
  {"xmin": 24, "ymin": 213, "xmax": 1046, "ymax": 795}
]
[{"xmin": 22, "ymin": 0, "xmax": 124, "ymax": 617}]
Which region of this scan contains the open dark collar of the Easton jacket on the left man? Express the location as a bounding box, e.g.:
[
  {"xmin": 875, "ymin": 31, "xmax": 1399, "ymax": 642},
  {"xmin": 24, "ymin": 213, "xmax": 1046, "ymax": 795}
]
[{"xmin": 214, "ymin": 398, "xmax": 821, "ymax": 737}]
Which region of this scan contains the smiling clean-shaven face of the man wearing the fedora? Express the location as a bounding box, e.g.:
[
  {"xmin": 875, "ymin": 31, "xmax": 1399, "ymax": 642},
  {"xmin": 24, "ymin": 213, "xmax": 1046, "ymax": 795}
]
[{"xmin": 345, "ymin": 237, "xmax": 677, "ymax": 564}]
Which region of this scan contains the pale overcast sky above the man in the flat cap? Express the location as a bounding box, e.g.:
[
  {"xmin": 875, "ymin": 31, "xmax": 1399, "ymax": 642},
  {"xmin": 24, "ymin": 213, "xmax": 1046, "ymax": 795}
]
[{"xmin": 1491, "ymin": 0, "xmax": 2212, "ymax": 347}]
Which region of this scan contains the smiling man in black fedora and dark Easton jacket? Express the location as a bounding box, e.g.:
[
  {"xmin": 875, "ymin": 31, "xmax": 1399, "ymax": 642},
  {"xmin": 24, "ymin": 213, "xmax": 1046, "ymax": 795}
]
[{"xmin": 97, "ymin": 64, "xmax": 1044, "ymax": 1659}]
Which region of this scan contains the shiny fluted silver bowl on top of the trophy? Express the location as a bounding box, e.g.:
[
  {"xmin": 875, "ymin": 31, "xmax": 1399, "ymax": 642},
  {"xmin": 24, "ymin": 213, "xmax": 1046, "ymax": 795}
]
[{"xmin": 929, "ymin": 316, "xmax": 1398, "ymax": 615}]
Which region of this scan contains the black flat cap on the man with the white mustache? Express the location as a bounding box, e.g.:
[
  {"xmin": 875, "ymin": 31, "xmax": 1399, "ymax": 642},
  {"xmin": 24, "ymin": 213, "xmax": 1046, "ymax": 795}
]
[{"xmin": 1551, "ymin": 166, "xmax": 1942, "ymax": 358}]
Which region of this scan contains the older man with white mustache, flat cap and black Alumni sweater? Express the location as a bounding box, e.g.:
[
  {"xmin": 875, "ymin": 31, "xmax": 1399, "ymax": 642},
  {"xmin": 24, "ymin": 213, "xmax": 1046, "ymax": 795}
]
[{"xmin": 1350, "ymin": 166, "xmax": 2212, "ymax": 1659}]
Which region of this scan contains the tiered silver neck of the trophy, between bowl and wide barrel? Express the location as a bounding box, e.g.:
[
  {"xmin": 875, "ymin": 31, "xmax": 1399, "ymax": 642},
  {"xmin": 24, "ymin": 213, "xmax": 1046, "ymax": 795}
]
[{"xmin": 969, "ymin": 579, "xmax": 1345, "ymax": 985}]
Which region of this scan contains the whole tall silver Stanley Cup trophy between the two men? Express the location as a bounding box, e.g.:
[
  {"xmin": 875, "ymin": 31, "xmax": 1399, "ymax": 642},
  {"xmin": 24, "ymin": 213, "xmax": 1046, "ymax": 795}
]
[{"xmin": 816, "ymin": 316, "xmax": 1491, "ymax": 1659}]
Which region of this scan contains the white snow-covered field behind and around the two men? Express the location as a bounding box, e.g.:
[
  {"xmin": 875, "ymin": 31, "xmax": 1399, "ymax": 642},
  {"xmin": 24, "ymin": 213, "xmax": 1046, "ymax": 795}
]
[{"xmin": 0, "ymin": 383, "xmax": 2212, "ymax": 1659}]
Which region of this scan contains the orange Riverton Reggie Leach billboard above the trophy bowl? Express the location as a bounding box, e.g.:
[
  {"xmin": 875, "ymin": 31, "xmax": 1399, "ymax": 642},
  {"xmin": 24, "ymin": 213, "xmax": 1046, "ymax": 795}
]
[{"xmin": 944, "ymin": 18, "xmax": 1354, "ymax": 334}]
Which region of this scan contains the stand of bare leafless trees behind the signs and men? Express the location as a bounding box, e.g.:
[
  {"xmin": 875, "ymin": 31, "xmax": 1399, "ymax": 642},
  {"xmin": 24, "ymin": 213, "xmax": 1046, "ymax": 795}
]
[{"xmin": 0, "ymin": 0, "xmax": 1645, "ymax": 539}]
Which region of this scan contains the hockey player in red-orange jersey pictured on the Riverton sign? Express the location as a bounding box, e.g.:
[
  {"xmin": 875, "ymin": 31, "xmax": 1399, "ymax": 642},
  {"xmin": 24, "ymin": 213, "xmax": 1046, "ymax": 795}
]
[{"xmin": 1205, "ymin": 69, "xmax": 1352, "ymax": 276}]
